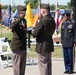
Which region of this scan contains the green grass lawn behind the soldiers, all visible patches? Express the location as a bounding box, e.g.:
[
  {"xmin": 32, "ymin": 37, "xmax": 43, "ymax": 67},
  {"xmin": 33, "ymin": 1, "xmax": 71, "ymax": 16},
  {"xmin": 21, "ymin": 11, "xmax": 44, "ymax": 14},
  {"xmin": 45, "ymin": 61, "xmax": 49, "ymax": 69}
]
[{"xmin": 0, "ymin": 26, "xmax": 63, "ymax": 58}]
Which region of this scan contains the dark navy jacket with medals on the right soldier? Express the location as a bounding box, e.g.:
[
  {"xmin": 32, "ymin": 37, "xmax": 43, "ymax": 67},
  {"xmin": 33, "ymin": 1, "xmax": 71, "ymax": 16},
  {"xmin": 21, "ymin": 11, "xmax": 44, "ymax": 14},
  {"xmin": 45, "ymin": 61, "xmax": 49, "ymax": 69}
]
[{"xmin": 61, "ymin": 20, "xmax": 76, "ymax": 47}]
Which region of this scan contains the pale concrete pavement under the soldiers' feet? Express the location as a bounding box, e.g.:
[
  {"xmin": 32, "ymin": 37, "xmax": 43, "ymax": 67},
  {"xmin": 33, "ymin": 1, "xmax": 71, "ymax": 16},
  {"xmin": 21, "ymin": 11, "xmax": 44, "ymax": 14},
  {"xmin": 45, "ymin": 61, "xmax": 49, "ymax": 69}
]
[{"xmin": 0, "ymin": 58, "xmax": 76, "ymax": 75}]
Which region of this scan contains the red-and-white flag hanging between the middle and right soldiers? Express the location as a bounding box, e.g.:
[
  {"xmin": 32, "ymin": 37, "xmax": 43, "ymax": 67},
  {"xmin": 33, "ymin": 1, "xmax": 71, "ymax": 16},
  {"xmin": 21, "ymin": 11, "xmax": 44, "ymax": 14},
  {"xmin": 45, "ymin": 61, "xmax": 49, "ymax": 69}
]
[{"xmin": 55, "ymin": 1, "xmax": 62, "ymax": 30}]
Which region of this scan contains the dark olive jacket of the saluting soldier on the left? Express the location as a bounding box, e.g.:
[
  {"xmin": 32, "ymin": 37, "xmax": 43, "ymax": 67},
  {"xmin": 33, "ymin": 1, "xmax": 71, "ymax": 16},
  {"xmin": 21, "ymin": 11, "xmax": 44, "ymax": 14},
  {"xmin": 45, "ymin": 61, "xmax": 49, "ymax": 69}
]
[{"xmin": 10, "ymin": 16, "xmax": 27, "ymax": 50}]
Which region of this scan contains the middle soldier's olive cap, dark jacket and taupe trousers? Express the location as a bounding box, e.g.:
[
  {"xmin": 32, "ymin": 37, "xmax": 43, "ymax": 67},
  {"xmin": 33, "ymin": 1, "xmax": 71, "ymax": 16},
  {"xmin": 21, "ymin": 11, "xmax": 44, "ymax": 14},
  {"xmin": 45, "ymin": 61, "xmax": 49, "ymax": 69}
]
[{"xmin": 32, "ymin": 4, "xmax": 55, "ymax": 75}]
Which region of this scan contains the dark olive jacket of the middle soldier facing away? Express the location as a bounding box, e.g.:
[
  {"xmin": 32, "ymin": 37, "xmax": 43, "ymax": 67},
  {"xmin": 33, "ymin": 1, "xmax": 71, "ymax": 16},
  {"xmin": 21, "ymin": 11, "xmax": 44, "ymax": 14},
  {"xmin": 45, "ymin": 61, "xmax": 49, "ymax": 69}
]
[{"xmin": 33, "ymin": 15, "xmax": 55, "ymax": 53}]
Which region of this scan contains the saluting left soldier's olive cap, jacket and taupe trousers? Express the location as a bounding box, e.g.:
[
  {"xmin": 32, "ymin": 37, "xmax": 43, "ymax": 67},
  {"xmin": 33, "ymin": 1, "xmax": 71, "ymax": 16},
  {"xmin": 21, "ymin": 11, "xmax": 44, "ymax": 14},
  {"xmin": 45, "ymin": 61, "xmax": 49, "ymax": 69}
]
[{"xmin": 10, "ymin": 6, "xmax": 27, "ymax": 75}]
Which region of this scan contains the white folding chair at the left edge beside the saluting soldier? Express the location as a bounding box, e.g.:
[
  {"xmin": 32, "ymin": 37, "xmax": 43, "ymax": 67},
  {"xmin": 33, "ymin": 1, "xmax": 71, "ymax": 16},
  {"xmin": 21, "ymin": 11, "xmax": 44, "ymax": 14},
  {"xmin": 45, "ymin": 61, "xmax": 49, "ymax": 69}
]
[{"xmin": 0, "ymin": 39, "xmax": 12, "ymax": 68}]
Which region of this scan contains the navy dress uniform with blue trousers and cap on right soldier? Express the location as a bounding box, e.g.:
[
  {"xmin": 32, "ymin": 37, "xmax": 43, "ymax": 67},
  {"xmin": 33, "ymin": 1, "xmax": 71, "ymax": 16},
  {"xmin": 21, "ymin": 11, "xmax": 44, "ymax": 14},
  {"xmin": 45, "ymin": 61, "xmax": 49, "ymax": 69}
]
[{"xmin": 61, "ymin": 13, "xmax": 76, "ymax": 74}]
